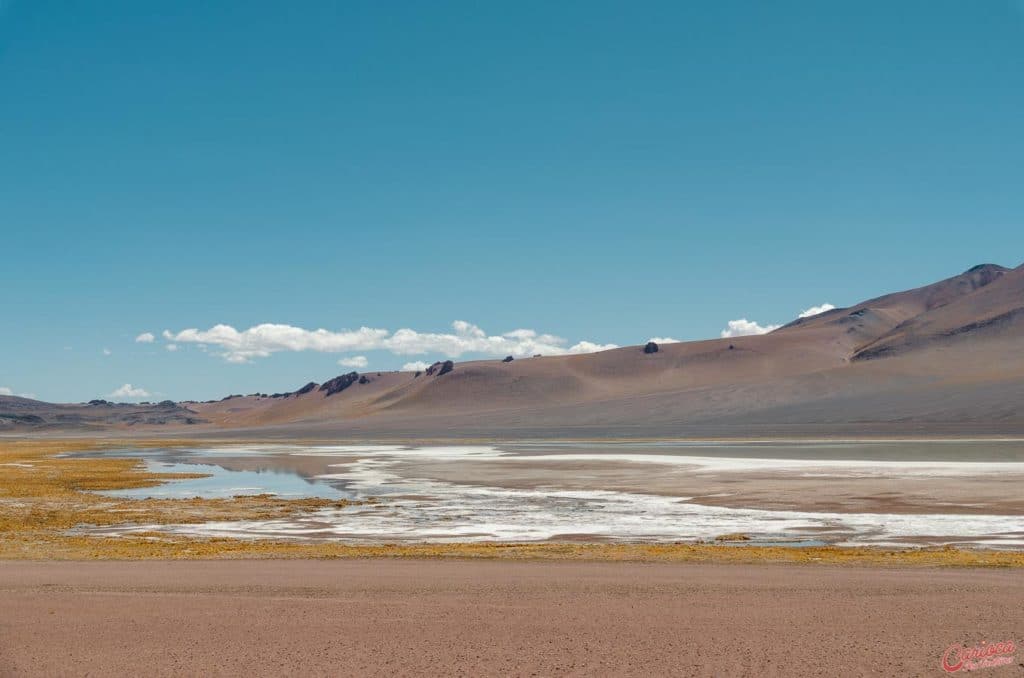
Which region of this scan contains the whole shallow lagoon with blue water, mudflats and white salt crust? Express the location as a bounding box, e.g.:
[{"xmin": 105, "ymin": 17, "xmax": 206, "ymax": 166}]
[{"xmin": 72, "ymin": 441, "xmax": 1024, "ymax": 548}]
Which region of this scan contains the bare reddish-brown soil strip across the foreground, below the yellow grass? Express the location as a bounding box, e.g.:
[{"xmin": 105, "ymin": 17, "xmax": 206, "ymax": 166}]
[{"xmin": 0, "ymin": 560, "xmax": 1024, "ymax": 676}]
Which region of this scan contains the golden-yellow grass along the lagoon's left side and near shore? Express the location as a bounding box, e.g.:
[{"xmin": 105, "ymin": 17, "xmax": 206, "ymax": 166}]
[{"xmin": 0, "ymin": 440, "xmax": 1024, "ymax": 567}]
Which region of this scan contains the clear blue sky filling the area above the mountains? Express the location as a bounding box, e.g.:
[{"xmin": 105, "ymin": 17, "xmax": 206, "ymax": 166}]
[{"xmin": 0, "ymin": 0, "xmax": 1024, "ymax": 400}]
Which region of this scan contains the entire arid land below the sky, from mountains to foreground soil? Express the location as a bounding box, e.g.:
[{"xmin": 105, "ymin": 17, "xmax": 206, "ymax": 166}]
[{"xmin": 0, "ymin": 265, "xmax": 1024, "ymax": 676}]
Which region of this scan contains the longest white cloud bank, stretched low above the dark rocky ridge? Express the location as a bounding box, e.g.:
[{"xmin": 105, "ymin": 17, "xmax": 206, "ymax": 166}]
[{"xmin": 163, "ymin": 321, "xmax": 617, "ymax": 363}]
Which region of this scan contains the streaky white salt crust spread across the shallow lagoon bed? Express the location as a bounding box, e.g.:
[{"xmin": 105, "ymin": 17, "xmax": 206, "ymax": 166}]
[{"xmin": 77, "ymin": 446, "xmax": 1024, "ymax": 548}]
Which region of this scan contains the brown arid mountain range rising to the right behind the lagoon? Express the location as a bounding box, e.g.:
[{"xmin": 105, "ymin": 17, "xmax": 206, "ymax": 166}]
[{"xmin": 0, "ymin": 264, "xmax": 1024, "ymax": 438}]
